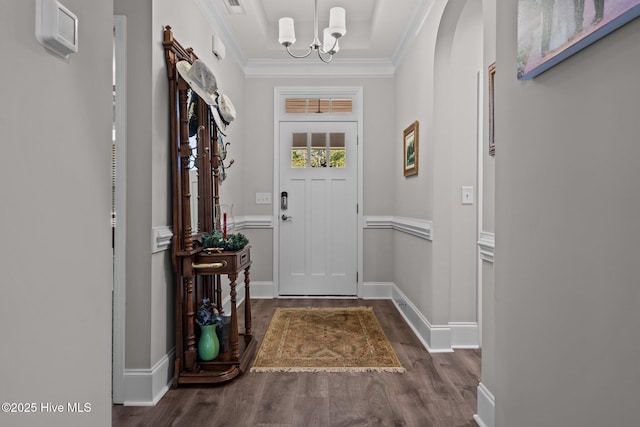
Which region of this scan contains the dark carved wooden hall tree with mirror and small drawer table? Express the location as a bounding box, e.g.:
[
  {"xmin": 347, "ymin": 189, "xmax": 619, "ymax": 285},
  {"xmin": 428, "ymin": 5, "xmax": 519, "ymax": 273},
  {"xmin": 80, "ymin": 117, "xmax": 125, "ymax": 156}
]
[{"xmin": 163, "ymin": 26, "xmax": 257, "ymax": 387}]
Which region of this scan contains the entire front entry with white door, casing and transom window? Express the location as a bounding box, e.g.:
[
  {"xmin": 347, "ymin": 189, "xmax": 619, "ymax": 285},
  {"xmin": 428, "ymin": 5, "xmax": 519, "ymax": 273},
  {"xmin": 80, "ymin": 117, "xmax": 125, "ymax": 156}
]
[{"xmin": 273, "ymin": 87, "xmax": 363, "ymax": 297}]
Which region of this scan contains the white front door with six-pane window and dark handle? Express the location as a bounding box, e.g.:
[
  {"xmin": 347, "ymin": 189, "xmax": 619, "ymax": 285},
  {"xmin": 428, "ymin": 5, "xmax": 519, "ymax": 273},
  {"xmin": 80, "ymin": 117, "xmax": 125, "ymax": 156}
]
[{"xmin": 276, "ymin": 122, "xmax": 358, "ymax": 295}]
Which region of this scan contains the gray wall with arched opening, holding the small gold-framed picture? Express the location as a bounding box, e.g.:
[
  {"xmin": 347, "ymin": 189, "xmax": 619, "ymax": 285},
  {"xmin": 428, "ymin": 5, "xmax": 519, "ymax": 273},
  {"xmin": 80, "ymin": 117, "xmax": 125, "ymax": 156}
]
[{"xmin": 394, "ymin": 1, "xmax": 482, "ymax": 325}]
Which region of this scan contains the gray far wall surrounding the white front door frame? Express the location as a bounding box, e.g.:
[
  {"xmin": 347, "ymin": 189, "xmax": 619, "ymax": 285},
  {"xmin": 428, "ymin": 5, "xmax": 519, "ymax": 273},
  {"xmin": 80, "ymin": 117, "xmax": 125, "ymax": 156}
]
[{"xmin": 240, "ymin": 78, "xmax": 398, "ymax": 282}]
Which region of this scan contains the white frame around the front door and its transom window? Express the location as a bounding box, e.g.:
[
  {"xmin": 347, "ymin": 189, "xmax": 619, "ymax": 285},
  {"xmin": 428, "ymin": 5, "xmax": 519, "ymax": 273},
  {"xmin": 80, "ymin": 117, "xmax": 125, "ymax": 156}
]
[{"xmin": 272, "ymin": 86, "xmax": 365, "ymax": 298}]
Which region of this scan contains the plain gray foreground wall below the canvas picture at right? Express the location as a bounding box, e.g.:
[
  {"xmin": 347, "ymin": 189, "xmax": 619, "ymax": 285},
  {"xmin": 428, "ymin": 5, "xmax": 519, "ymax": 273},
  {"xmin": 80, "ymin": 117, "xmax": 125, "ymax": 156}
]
[{"xmin": 495, "ymin": 2, "xmax": 640, "ymax": 427}]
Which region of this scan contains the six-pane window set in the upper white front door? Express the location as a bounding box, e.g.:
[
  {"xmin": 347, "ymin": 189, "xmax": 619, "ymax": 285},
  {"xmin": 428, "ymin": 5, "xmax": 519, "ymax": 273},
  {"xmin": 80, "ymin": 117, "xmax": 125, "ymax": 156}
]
[{"xmin": 291, "ymin": 132, "xmax": 347, "ymax": 169}]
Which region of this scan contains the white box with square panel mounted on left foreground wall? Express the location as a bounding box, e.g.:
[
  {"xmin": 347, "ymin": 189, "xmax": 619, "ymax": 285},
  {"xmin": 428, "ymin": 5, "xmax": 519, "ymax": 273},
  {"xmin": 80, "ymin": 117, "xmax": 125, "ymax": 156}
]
[{"xmin": 36, "ymin": 0, "xmax": 78, "ymax": 58}]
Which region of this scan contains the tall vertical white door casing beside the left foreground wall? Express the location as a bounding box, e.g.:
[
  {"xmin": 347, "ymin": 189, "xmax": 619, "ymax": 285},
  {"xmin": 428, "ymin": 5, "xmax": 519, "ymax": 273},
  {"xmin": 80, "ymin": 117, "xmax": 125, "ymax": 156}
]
[{"xmin": 109, "ymin": 15, "xmax": 127, "ymax": 403}]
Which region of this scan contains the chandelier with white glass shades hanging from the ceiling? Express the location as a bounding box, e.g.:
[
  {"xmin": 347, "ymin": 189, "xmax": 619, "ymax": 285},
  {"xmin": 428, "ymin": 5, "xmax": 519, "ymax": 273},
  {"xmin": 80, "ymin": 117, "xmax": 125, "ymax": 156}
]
[{"xmin": 278, "ymin": 0, "xmax": 347, "ymax": 63}]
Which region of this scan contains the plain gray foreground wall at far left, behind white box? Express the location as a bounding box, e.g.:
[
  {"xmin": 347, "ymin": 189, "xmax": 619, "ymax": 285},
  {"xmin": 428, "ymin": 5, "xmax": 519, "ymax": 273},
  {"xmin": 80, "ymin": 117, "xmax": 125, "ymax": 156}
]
[{"xmin": 0, "ymin": 0, "xmax": 113, "ymax": 426}]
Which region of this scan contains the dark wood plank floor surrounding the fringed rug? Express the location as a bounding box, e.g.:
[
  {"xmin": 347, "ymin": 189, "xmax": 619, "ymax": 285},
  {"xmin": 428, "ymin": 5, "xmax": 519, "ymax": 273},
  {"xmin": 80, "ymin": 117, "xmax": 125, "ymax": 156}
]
[{"xmin": 113, "ymin": 299, "xmax": 480, "ymax": 427}]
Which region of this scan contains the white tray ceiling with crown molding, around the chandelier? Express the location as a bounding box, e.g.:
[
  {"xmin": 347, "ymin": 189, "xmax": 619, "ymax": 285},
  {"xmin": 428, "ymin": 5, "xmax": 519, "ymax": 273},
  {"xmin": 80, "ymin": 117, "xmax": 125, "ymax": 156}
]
[{"xmin": 198, "ymin": 0, "xmax": 433, "ymax": 75}]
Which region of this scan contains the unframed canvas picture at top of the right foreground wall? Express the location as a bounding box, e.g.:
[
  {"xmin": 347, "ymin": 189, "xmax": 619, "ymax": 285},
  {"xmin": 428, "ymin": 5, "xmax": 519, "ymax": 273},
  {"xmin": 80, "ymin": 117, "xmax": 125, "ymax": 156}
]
[{"xmin": 518, "ymin": 0, "xmax": 640, "ymax": 80}]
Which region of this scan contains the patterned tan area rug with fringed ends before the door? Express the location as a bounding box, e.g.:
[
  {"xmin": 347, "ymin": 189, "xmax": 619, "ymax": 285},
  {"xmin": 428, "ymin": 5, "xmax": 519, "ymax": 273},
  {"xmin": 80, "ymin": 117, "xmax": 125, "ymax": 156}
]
[{"xmin": 251, "ymin": 307, "xmax": 405, "ymax": 372}]
